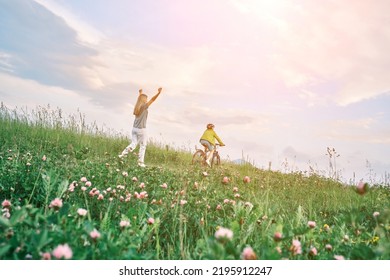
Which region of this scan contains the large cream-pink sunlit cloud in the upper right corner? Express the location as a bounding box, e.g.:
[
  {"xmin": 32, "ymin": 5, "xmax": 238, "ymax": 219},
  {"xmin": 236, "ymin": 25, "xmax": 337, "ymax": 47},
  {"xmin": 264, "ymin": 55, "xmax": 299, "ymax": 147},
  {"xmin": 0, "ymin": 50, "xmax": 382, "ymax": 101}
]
[{"xmin": 233, "ymin": 0, "xmax": 390, "ymax": 106}]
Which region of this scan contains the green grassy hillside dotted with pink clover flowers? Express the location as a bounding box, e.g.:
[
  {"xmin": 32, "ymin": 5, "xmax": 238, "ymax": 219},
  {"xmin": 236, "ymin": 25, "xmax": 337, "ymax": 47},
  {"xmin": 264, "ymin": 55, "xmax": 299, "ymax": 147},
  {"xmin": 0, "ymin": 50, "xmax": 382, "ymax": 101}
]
[{"xmin": 0, "ymin": 105, "xmax": 390, "ymax": 260}]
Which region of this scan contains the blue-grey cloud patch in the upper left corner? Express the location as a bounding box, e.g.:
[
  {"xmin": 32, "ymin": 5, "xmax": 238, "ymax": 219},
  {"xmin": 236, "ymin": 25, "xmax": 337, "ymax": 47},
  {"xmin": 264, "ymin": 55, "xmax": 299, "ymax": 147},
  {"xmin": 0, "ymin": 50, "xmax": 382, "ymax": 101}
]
[{"xmin": 0, "ymin": 0, "xmax": 99, "ymax": 89}]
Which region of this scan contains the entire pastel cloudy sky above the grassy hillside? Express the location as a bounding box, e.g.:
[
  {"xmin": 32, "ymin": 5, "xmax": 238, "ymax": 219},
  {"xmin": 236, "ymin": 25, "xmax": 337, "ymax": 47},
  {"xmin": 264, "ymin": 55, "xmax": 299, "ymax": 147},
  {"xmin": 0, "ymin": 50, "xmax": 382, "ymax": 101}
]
[{"xmin": 0, "ymin": 0, "xmax": 390, "ymax": 183}]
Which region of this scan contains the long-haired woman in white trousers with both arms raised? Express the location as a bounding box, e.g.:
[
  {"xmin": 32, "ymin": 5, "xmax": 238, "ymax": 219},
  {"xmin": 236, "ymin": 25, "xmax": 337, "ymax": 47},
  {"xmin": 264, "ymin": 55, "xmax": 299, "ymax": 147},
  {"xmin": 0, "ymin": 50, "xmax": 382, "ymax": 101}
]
[{"xmin": 119, "ymin": 88, "xmax": 162, "ymax": 167}]
